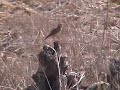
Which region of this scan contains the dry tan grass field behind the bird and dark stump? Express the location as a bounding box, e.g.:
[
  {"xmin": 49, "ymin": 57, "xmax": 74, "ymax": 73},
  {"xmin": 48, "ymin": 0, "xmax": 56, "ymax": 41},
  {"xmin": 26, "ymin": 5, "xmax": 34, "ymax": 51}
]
[{"xmin": 0, "ymin": 0, "xmax": 120, "ymax": 90}]
